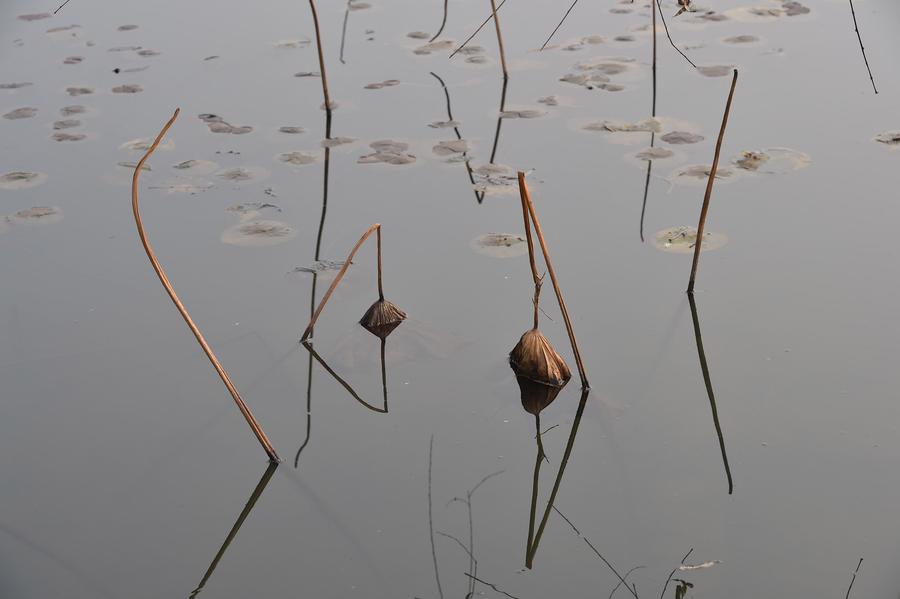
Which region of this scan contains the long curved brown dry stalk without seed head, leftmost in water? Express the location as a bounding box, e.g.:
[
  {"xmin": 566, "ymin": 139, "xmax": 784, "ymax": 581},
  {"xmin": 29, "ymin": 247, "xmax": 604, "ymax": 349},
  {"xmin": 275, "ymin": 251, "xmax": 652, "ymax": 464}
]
[{"xmin": 131, "ymin": 108, "xmax": 281, "ymax": 462}]
